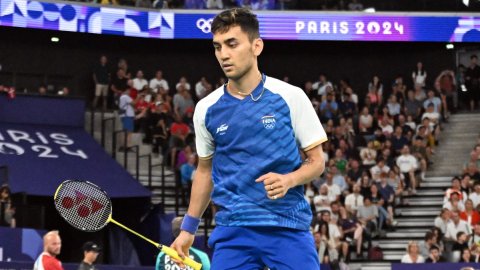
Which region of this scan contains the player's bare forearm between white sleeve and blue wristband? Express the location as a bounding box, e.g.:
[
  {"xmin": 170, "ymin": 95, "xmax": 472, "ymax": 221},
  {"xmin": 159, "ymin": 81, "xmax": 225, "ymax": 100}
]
[{"xmin": 187, "ymin": 160, "xmax": 213, "ymax": 218}]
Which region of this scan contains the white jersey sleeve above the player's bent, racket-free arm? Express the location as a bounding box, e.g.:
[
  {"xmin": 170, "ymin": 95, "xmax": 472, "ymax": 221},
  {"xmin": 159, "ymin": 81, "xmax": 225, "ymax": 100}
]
[{"xmin": 290, "ymin": 88, "xmax": 327, "ymax": 151}]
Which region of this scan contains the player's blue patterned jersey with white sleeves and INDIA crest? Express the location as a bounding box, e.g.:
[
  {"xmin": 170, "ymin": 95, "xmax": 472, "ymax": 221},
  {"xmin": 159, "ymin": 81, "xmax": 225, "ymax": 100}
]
[{"xmin": 194, "ymin": 76, "xmax": 327, "ymax": 230}]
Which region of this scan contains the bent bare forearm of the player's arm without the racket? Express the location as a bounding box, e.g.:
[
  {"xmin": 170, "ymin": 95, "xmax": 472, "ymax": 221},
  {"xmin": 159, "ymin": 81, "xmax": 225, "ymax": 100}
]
[{"xmin": 288, "ymin": 145, "xmax": 325, "ymax": 187}]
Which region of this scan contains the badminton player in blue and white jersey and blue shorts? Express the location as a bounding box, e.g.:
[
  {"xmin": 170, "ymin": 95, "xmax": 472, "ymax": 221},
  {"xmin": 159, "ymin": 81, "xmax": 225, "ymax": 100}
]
[{"xmin": 172, "ymin": 8, "xmax": 327, "ymax": 270}]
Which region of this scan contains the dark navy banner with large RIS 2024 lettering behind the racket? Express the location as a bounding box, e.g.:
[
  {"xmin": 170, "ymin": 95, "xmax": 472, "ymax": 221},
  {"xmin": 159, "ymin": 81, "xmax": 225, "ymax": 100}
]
[{"xmin": 0, "ymin": 95, "xmax": 151, "ymax": 198}]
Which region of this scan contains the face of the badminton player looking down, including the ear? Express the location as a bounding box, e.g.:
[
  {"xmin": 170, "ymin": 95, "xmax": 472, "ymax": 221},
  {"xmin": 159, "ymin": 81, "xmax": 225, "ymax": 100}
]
[{"xmin": 213, "ymin": 26, "xmax": 263, "ymax": 80}]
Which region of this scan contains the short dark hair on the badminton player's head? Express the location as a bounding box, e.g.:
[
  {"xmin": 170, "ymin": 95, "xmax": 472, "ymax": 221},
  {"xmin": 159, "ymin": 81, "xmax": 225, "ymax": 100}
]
[{"xmin": 211, "ymin": 8, "xmax": 260, "ymax": 41}]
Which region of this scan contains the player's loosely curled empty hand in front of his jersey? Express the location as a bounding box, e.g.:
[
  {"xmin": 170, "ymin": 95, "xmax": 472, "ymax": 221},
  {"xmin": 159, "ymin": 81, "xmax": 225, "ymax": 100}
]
[{"xmin": 255, "ymin": 172, "xmax": 293, "ymax": 200}]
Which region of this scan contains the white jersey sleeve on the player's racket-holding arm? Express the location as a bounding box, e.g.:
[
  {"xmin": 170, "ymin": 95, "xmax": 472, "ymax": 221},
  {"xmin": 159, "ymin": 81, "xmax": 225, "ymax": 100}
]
[{"xmin": 193, "ymin": 103, "xmax": 215, "ymax": 159}]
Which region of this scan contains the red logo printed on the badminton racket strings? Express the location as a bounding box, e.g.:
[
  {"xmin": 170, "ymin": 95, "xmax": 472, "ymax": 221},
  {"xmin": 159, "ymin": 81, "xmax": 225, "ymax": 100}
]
[{"xmin": 61, "ymin": 191, "xmax": 104, "ymax": 218}]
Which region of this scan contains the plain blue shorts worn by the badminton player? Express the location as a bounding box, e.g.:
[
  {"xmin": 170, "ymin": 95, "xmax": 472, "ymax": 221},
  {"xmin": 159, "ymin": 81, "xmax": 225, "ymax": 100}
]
[{"xmin": 208, "ymin": 226, "xmax": 320, "ymax": 270}]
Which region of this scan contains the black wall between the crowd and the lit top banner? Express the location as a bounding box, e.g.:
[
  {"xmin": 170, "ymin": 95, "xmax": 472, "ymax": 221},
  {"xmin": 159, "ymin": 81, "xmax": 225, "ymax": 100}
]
[{"xmin": 0, "ymin": 27, "xmax": 464, "ymax": 101}]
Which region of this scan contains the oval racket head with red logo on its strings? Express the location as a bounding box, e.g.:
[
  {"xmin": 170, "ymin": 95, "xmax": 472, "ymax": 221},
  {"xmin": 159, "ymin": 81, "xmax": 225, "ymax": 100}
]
[{"xmin": 53, "ymin": 180, "xmax": 112, "ymax": 232}]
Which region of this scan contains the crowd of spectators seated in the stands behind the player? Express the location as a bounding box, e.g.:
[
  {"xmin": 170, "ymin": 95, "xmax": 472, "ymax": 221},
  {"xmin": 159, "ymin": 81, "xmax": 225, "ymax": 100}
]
[{"xmin": 86, "ymin": 52, "xmax": 480, "ymax": 263}]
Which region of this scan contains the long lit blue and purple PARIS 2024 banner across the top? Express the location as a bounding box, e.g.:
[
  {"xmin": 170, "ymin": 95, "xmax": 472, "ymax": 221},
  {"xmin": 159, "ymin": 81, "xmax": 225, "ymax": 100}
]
[{"xmin": 0, "ymin": 0, "xmax": 480, "ymax": 42}]
